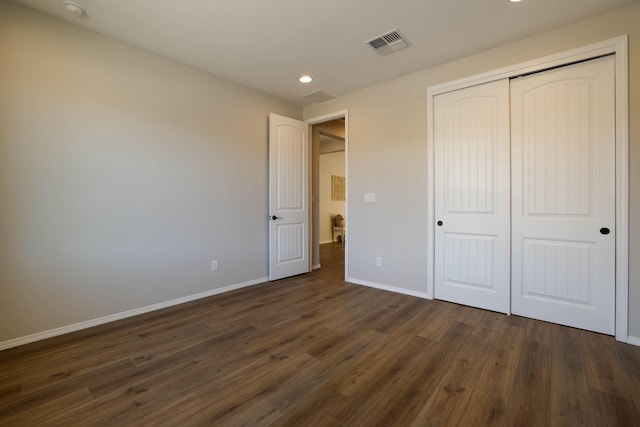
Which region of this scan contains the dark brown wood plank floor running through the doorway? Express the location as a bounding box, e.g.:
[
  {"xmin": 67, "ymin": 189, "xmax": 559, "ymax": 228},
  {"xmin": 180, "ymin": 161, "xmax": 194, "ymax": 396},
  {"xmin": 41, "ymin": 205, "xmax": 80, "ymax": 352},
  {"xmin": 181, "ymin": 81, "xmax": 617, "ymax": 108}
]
[{"xmin": 0, "ymin": 244, "xmax": 640, "ymax": 426}]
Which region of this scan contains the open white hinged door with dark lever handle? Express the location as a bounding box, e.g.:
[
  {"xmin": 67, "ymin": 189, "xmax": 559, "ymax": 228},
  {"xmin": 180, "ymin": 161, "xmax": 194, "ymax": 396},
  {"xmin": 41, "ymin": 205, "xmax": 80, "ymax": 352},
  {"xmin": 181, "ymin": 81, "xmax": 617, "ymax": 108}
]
[{"xmin": 268, "ymin": 114, "xmax": 310, "ymax": 280}]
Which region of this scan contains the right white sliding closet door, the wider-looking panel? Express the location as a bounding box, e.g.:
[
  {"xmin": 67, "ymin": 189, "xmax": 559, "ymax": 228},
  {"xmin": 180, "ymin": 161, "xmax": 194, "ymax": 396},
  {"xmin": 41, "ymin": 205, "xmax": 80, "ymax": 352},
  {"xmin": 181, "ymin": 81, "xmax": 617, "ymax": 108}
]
[{"xmin": 511, "ymin": 56, "xmax": 615, "ymax": 334}]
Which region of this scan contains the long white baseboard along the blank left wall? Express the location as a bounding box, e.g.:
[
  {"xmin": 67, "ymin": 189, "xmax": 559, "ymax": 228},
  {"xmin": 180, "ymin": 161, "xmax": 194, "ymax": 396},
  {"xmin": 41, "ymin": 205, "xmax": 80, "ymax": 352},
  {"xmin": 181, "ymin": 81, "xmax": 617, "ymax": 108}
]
[{"xmin": 0, "ymin": 277, "xmax": 269, "ymax": 351}]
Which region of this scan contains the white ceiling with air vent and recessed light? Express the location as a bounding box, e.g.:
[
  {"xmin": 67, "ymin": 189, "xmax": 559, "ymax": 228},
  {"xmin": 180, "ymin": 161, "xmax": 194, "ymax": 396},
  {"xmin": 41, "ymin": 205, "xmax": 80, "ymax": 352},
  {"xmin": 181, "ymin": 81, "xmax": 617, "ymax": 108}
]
[{"xmin": 14, "ymin": 0, "xmax": 640, "ymax": 106}]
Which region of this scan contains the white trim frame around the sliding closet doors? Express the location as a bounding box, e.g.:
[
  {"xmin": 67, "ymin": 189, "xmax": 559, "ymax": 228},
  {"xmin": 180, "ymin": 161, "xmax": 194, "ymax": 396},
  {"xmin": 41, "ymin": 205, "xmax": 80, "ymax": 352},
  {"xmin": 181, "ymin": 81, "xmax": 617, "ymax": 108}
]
[{"xmin": 426, "ymin": 35, "xmax": 629, "ymax": 342}]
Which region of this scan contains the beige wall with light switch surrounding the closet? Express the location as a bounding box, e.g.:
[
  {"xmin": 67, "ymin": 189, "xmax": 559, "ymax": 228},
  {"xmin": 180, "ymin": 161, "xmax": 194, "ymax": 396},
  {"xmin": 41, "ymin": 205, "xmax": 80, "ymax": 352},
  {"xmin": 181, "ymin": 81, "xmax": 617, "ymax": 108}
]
[{"xmin": 304, "ymin": 5, "xmax": 640, "ymax": 337}]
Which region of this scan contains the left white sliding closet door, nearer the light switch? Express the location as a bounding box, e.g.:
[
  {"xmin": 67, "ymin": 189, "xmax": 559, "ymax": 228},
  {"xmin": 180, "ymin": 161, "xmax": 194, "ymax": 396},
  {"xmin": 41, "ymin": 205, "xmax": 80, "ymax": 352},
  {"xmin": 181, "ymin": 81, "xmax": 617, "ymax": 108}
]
[{"xmin": 434, "ymin": 79, "xmax": 510, "ymax": 313}]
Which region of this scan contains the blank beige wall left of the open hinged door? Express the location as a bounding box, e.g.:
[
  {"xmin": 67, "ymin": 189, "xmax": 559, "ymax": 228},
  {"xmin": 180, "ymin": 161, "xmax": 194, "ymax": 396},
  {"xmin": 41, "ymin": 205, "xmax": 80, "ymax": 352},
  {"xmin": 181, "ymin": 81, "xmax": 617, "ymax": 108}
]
[{"xmin": 0, "ymin": 2, "xmax": 302, "ymax": 343}]
